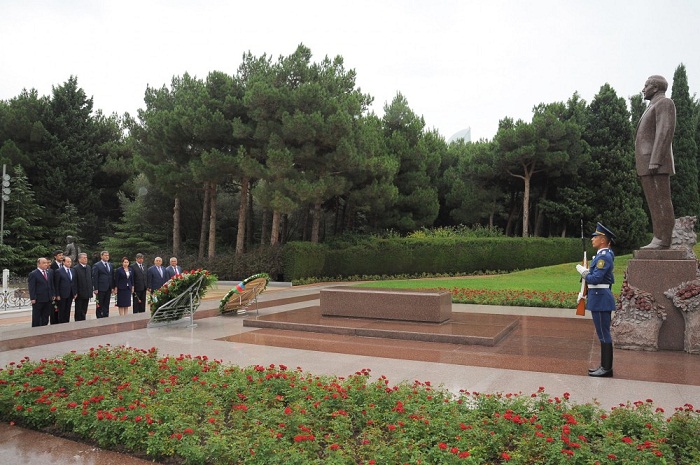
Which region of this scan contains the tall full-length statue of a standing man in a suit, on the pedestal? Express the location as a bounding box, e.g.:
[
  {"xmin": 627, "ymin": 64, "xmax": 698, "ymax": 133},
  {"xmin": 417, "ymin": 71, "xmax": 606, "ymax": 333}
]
[{"xmin": 634, "ymin": 76, "xmax": 676, "ymax": 249}]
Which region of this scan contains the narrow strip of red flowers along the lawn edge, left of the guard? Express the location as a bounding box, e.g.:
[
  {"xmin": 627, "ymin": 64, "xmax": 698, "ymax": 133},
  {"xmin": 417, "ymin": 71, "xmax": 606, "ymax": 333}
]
[{"xmin": 438, "ymin": 287, "xmax": 578, "ymax": 308}]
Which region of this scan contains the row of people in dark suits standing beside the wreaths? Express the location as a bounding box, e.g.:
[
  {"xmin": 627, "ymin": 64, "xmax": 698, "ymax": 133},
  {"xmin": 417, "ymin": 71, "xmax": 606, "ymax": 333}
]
[{"xmin": 28, "ymin": 250, "xmax": 182, "ymax": 326}]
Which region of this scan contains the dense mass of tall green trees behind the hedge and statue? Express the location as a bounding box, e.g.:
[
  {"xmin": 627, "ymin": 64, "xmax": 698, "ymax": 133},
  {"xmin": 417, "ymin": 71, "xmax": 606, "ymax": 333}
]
[{"xmin": 0, "ymin": 45, "xmax": 700, "ymax": 271}]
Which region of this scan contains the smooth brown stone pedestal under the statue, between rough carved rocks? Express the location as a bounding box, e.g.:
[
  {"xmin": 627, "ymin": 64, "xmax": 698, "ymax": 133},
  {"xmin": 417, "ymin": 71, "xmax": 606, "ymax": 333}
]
[{"xmin": 627, "ymin": 249, "xmax": 697, "ymax": 350}]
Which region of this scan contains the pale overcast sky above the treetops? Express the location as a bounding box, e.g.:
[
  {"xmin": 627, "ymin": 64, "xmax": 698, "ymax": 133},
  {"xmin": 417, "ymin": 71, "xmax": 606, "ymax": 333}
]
[{"xmin": 0, "ymin": 0, "xmax": 700, "ymax": 140}]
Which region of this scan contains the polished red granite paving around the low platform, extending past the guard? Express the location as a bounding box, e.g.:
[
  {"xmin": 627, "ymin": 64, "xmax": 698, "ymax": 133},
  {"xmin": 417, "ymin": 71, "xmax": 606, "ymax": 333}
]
[{"xmin": 223, "ymin": 307, "xmax": 700, "ymax": 386}]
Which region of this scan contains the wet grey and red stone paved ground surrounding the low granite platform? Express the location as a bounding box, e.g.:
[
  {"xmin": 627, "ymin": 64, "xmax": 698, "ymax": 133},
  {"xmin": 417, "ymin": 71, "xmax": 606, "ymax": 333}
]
[{"xmin": 0, "ymin": 283, "xmax": 700, "ymax": 465}]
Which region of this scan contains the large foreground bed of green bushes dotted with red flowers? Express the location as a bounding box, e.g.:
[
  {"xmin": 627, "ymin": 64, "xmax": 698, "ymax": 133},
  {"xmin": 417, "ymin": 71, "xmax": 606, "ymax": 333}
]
[{"xmin": 0, "ymin": 346, "xmax": 700, "ymax": 465}]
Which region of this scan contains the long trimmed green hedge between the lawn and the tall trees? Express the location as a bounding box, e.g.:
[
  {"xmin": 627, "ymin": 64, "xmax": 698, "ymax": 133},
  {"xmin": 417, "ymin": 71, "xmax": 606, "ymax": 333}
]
[{"xmin": 283, "ymin": 237, "xmax": 581, "ymax": 281}]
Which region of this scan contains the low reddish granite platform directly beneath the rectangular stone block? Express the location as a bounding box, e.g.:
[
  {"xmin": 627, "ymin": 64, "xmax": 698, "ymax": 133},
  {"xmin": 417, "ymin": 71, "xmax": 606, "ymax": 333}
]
[{"xmin": 243, "ymin": 306, "xmax": 518, "ymax": 346}]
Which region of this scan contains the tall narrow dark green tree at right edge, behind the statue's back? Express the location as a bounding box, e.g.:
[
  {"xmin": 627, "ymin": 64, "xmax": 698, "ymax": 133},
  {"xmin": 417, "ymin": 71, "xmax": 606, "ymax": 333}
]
[{"xmin": 671, "ymin": 64, "xmax": 700, "ymax": 217}]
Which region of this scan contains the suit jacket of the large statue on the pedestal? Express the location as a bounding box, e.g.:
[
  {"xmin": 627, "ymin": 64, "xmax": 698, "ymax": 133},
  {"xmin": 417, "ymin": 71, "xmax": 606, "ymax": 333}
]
[{"xmin": 634, "ymin": 93, "xmax": 676, "ymax": 176}]
